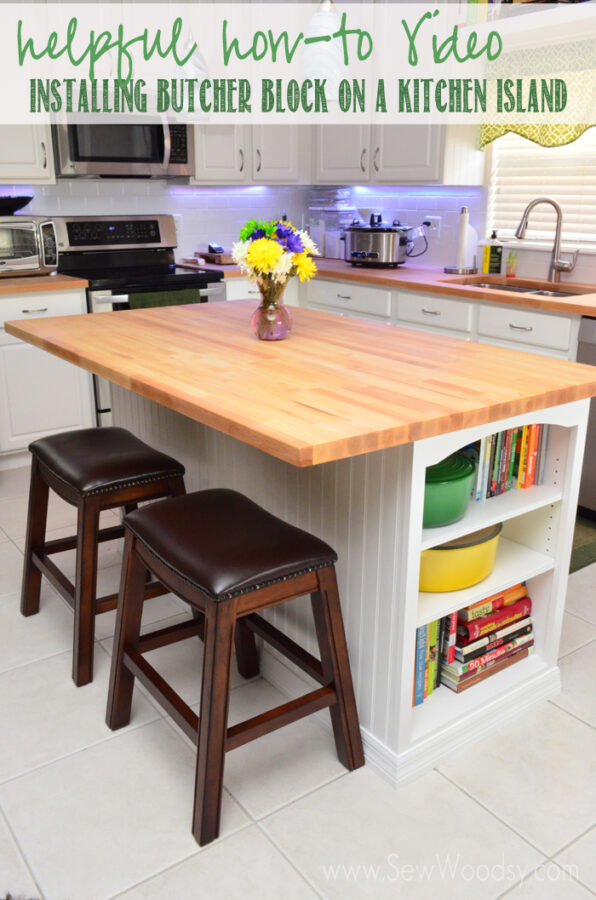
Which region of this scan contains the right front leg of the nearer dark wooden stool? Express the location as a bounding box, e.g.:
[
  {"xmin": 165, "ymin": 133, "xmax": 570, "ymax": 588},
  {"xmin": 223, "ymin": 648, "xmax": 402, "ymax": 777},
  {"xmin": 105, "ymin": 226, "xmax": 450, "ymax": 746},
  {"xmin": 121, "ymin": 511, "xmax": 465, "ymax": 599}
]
[{"xmin": 311, "ymin": 566, "xmax": 364, "ymax": 769}]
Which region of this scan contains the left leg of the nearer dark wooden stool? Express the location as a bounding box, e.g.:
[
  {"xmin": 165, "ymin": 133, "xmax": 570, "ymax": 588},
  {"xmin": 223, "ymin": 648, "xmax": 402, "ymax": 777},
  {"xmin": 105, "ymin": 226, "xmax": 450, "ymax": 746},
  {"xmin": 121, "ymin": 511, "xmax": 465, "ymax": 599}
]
[{"xmin": 106, "ymin": 529, "xmax": 147, "ymax": 730}]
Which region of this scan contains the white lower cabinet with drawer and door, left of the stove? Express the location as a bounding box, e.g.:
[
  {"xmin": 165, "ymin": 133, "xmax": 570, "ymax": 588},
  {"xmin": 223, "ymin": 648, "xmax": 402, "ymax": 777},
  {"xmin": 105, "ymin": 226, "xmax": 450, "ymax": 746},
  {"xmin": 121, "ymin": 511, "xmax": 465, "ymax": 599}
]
[{"xmin": 0, "ymin": 291, "xmax": 95, "ymax": 453}]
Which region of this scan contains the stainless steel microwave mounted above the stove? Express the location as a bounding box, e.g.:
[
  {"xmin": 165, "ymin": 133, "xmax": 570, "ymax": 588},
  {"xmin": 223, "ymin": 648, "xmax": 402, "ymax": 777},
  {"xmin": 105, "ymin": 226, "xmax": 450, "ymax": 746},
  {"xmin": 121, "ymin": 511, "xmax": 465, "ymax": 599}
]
[{"xmin": 52, "ymin": 122, "xmax": 194, "ymax": 178}]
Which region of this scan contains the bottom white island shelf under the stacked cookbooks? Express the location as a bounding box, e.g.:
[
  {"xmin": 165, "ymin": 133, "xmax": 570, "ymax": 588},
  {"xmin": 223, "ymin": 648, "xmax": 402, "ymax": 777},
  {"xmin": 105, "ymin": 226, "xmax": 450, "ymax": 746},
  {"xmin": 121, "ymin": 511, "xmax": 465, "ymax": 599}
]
[{"xmin": 412, "ymin": 653, "xmax": 548, "ymax": 743}]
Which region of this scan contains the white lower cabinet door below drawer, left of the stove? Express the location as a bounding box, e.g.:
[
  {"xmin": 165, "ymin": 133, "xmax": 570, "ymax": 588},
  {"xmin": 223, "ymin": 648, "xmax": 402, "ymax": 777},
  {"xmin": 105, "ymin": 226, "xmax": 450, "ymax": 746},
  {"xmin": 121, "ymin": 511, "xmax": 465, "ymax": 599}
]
[{"xmin": 0, "ymin": 341, "xmax": 94, "ymax": 451}]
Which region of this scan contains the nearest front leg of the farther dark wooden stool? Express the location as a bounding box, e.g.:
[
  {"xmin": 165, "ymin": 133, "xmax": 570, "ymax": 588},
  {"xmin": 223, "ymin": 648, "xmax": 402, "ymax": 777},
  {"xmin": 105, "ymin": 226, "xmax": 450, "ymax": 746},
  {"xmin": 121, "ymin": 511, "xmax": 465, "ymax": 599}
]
[{"xmin": 72, "ymin": 498, "xmax": 99, "ymax": 687}]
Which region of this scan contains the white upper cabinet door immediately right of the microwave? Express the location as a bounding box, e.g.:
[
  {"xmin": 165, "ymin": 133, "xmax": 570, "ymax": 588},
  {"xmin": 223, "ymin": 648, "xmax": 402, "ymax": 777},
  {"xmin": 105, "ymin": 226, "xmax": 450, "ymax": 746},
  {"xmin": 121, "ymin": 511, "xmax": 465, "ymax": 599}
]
[{"xmin": 192, "ymin": 125, "xmax": 251, "ymax": 184}]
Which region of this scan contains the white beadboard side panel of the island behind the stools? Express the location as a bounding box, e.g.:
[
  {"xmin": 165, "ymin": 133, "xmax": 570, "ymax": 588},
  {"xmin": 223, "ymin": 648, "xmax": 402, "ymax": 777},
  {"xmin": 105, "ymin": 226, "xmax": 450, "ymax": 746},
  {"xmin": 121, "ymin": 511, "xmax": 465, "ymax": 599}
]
[{"xmin": 112, "ymin": 386, "xmax": 412, "ymax": 750}]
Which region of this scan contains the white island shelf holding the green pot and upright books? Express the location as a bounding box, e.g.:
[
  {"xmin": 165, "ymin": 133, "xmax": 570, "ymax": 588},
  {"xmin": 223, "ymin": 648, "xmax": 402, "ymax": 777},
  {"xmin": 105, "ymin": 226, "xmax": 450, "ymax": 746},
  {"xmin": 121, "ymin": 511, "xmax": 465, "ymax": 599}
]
[{"xmin": 420, "ymin": 484, "xmax": 563, "ymax": 550}]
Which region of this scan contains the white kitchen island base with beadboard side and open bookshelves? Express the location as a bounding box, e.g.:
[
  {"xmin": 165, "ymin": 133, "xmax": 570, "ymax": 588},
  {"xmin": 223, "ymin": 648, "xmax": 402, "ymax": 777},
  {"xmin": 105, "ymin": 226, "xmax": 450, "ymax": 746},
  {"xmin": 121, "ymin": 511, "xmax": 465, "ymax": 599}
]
[{"xmin": 112, "ymin": 386, "xmax": 589, "ymax": 784}]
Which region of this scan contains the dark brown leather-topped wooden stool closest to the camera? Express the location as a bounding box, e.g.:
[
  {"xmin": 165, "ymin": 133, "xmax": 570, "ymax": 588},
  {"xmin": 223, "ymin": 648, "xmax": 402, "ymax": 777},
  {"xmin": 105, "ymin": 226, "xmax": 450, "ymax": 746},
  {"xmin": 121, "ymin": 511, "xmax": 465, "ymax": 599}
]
[{"xmin": 107, "ymin": 489, "xmax": 364, "ymax": 845}]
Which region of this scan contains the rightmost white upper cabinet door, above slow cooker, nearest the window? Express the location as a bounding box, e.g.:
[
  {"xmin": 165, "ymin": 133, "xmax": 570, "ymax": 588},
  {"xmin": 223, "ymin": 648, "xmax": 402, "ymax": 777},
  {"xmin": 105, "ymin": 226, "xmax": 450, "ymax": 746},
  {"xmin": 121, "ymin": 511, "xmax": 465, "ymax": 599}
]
[{"xmin": 371, "ymin": 125, "xmax": 445, "ymax": 184}]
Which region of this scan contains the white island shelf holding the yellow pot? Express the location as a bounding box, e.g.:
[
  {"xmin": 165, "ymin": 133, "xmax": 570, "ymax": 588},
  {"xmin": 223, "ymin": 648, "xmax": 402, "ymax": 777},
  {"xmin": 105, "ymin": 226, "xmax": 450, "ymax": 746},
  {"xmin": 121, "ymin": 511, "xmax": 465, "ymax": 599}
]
[{"xmin": 416, "ymin": 537, "xmax": 555, "ymax": 628}]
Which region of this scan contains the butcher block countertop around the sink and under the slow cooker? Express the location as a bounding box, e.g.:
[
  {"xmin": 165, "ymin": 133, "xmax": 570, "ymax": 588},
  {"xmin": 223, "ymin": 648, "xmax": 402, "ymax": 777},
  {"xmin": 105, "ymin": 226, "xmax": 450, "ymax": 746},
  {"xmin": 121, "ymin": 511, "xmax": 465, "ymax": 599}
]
[{"xmin": 201, "ymin": 259, "xmax": 596, "ymax": 316}]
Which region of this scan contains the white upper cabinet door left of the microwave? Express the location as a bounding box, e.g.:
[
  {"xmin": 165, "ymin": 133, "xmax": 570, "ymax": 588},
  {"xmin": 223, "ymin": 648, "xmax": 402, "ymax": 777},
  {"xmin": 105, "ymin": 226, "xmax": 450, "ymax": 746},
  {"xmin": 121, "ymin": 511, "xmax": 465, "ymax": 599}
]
[{"xmin": 0, "ymin": 125, "xmax": 56, "ymax": 184}]
